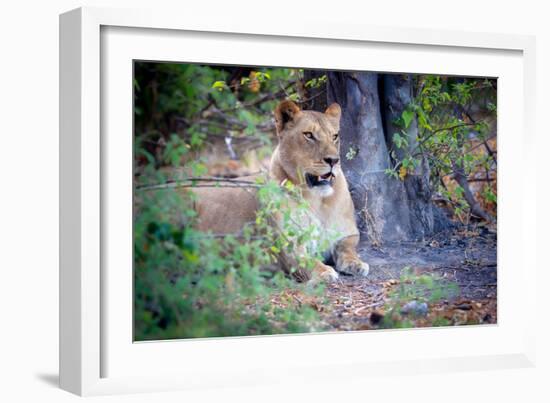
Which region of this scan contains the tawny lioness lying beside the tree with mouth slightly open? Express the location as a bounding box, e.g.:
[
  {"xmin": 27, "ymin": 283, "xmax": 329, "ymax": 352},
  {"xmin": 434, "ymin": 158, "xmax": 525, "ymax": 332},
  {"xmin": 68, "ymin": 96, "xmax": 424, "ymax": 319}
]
[{"xmin": 197, "ymin": 100, "xmax": 369, "ymax": 282}]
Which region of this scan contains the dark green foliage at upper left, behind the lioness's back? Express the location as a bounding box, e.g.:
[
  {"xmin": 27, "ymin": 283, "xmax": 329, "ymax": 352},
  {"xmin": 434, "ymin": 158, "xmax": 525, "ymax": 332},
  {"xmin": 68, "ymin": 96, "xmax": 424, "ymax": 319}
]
[{"xmin": 134, "ymin": 62, "xmax": 306, "ymax": 165}]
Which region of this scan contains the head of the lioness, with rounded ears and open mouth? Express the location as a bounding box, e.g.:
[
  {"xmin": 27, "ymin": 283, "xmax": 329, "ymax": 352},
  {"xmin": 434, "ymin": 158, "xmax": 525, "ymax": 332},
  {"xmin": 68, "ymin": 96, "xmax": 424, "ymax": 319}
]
[{"xmin": 275, "ymin": 100, "xmax": 342, "ymax": 197}]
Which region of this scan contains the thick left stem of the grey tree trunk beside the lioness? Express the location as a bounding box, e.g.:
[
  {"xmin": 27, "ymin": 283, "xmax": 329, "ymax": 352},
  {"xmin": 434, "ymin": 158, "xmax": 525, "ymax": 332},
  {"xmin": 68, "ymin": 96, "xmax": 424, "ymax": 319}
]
[{"xmin": 328, "ymin": 72, "xmax": 410, "ymax": 244}]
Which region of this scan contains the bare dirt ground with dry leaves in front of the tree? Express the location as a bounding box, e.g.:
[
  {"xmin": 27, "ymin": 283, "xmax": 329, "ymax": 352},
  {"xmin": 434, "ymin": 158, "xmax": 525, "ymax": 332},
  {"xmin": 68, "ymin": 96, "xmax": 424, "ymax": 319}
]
[{"xmin": 321, "ymin": 227, "xmax": 497, "ymax": 330}]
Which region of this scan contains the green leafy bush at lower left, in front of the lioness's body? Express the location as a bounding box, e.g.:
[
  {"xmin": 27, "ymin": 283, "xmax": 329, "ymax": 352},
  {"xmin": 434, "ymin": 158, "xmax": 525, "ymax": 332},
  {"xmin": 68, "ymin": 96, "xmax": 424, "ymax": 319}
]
[{"xmin": 134, "ymin": 172, "xmax": 332, "ymax": 340}]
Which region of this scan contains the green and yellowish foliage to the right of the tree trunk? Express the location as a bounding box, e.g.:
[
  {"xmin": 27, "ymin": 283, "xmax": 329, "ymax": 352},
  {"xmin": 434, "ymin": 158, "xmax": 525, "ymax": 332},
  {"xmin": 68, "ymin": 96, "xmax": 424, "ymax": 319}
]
[{"xmin": 386, "ymin": 75, "xmax": 496, "ymax": 221}]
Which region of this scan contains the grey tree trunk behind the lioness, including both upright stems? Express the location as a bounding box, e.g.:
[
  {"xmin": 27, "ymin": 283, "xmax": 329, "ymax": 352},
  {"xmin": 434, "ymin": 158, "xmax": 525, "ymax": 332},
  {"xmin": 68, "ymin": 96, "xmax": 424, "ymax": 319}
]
[{"xmin": 327, "ymin": 72, "xmax": 448, "ymax": 244}]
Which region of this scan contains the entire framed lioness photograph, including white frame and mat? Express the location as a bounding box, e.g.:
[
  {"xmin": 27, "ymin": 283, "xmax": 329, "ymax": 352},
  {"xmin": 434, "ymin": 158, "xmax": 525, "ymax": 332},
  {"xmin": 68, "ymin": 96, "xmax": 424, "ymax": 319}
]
[{"xmin": 60, "ymin": 8, "xmax": 536, "ymax": 395}]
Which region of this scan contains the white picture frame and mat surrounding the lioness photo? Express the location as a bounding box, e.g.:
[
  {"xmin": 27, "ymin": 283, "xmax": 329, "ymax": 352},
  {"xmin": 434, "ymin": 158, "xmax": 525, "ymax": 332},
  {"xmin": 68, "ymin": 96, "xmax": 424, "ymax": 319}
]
[{"xmin": 60, "ymin": 8, "xmax": 537, "ymax": 395}]
